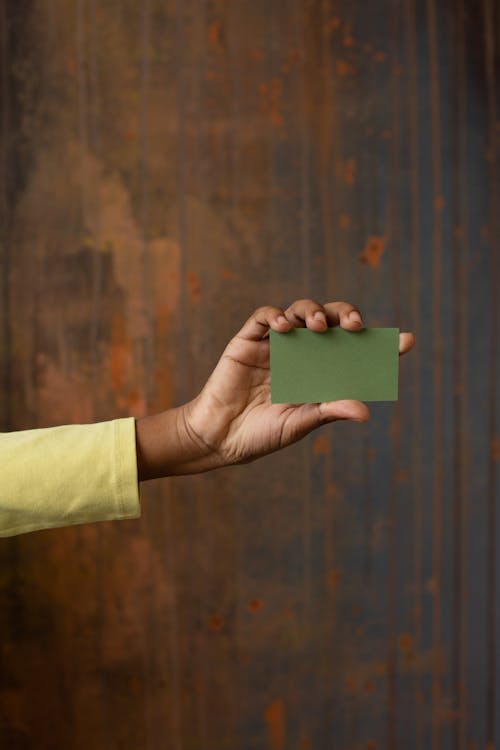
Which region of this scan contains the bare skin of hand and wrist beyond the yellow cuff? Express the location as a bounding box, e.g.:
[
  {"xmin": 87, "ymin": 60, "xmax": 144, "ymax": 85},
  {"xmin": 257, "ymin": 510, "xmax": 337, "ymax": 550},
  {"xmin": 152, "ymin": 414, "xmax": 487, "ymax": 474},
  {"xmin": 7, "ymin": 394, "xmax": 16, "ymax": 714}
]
[{"xmin": 136, "ymin": 299, "xmax": 415, "ymax": 481}]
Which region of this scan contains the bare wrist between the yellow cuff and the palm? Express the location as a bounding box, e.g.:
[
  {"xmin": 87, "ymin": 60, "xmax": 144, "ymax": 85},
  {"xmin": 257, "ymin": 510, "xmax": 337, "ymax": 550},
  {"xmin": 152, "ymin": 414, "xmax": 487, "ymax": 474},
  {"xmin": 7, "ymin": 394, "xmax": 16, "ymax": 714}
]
[{"xmin": 135, "ymin": 403, "xmax": 222, "ymax": 482}]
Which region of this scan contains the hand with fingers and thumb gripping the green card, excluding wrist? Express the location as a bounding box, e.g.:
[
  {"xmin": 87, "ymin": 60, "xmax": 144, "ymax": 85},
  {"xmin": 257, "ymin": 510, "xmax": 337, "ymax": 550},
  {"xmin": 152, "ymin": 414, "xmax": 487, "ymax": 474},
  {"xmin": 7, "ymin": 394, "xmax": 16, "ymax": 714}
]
[{"xmin": 181, "ymin": 300, "xmax": 415, "ymax": 473}]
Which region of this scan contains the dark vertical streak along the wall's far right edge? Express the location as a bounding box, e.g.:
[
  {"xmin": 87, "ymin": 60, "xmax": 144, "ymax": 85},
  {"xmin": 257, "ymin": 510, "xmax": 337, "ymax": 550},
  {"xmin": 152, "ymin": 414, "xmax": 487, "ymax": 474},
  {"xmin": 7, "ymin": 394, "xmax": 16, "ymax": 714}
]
[{"xmin": 483, "ymin": 0, "xmax": 500, "ymax": 747}]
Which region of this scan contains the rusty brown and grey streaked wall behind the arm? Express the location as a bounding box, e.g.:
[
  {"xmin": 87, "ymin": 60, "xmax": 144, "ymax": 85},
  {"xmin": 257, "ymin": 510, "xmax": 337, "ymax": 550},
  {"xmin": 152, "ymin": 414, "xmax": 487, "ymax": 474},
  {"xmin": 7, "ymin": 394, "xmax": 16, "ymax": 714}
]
[{"xmin": 0, "ymin": 0, "xmax": 500, "ymax": 750}]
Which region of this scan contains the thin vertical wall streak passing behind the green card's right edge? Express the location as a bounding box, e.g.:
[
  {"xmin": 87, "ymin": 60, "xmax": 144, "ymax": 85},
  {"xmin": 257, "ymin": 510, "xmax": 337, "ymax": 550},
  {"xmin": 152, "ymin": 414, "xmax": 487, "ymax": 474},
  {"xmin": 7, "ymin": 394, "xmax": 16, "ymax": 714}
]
[{"xmin": 387, "ymin": 1, "xmax": 401, "ymax": 750}]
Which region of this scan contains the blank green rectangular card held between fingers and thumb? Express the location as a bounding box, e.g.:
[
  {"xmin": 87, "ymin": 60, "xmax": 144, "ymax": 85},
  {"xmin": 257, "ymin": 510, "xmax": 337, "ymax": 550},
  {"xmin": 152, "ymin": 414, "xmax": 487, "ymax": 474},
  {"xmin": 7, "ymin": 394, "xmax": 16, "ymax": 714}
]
[{"xmin": 269, "ymin": 327, "xmax": 399, "ymax": 404}]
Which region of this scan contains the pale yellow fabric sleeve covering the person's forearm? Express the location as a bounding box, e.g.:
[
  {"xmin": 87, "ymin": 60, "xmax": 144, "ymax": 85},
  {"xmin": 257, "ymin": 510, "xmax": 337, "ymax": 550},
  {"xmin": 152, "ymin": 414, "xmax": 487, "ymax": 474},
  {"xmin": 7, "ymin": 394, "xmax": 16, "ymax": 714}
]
[{"xmin": 0, "ymin": 417, "xmax": 141, "ymax": 536}]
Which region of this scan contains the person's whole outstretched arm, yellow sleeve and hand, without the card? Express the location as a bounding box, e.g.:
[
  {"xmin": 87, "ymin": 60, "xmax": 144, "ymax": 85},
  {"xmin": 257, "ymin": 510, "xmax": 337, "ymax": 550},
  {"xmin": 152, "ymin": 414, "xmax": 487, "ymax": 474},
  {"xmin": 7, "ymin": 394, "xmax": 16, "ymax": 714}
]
[{"xmin": 0, "ymin": 300, "xmax": 413, "ymax": 536}]
